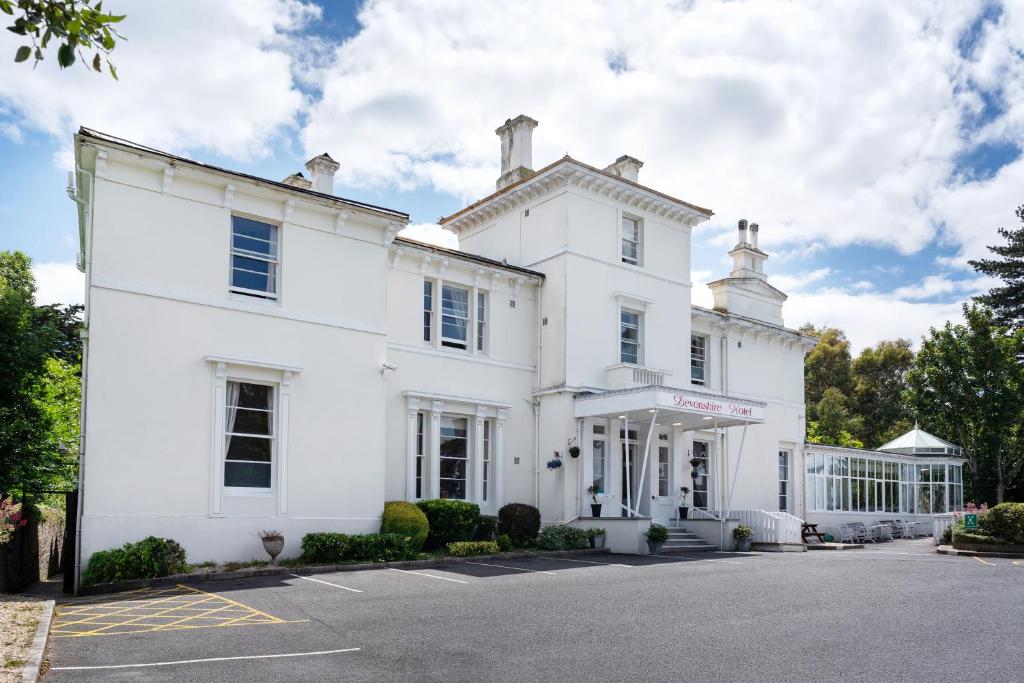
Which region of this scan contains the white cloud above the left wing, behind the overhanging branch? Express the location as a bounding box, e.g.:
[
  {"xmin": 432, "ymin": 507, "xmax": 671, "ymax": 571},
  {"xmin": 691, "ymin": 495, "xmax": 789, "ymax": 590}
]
[{"xmin": 0, "ymin": 0, "xmax": 319, "ymax": 164}]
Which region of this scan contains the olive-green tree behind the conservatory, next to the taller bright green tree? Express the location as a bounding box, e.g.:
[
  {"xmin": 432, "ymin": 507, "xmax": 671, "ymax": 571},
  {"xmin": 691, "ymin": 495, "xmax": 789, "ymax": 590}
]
[{"xmin": 851, "ymin": 339, "xmax": 913, "ymax": 449}]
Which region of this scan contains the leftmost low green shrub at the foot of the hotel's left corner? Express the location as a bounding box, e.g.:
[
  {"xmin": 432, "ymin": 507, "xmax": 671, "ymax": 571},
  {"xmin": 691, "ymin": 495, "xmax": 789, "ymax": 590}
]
[{"xmin": 82, "ymin": 536, "xmax": 188, "ymax": 586}]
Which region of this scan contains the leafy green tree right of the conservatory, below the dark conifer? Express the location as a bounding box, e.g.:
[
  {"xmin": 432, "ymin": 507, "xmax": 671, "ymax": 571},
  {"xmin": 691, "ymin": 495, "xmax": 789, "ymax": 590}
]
[{"xmin": 907, "ymin": 304, "xmax": 1024, "ymax": 503}]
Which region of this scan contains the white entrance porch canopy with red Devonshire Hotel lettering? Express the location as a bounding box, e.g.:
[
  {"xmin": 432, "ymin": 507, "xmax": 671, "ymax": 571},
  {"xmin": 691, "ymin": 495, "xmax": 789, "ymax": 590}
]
[{"xmin": 574, "ymin": 386, "xmax": 766, "ymax": 431}]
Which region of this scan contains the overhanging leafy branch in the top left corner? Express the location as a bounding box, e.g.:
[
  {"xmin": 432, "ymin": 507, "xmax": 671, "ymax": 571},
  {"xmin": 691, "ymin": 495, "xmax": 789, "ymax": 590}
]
[{"xmin": 0, "ymin": 0, "xmax": 125, "ymax": 80}]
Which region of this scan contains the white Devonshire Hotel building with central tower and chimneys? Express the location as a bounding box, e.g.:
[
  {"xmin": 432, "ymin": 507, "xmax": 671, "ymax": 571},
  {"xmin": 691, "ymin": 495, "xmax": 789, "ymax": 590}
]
[{"xmin": 68, "ymin": 116, "xmax": 959, "ymax": 577}]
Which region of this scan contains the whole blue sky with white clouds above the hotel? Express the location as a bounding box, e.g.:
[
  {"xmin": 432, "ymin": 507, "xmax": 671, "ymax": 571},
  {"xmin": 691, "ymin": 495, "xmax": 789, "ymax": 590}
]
[{"xmin": 0, "ymin": 0, "xmax": 1024, "ymax": 346}]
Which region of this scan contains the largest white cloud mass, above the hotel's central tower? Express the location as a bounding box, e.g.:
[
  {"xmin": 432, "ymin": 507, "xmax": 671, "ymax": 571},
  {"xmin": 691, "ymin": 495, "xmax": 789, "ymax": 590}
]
[{"xmin": 303, "ymin": 0, "xmax": 1024, "ymax": 258}]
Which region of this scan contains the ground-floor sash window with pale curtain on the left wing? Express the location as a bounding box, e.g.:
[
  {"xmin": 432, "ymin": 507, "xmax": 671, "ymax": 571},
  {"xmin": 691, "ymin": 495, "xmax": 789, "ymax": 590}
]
[{"xmin": 224, "ymin": 381, "xmax": 275, "ymax": 490}]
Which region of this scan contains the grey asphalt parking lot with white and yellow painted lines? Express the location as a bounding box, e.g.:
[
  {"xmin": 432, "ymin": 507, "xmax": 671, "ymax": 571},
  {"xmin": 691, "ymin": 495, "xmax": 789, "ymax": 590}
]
[{"xmin": 45, "ymin": 541, "xmax": 1024, "ymax": 682}]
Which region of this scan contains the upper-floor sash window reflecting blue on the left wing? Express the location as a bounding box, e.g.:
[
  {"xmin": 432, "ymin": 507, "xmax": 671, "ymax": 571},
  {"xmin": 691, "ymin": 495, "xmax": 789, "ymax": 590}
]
[{"xmin": 230, "ymin": 216, "xmax": 279, "ymax": 299}]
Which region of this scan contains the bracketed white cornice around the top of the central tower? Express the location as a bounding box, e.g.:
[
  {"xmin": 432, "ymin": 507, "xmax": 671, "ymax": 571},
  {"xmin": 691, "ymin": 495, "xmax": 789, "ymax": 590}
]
[{"xmin": 438, "ymin": 156, "xmax": 714, "ymax": 234}]
